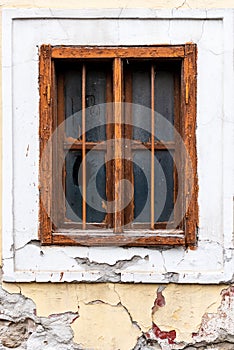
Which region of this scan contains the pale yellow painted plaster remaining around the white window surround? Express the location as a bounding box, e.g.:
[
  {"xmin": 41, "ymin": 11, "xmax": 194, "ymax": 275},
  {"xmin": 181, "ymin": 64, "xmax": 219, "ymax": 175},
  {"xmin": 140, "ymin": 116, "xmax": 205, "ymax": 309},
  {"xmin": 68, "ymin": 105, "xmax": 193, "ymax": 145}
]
[{"xmin": 0, "ymin": 0, "xmax": 234, "ymax": 350}]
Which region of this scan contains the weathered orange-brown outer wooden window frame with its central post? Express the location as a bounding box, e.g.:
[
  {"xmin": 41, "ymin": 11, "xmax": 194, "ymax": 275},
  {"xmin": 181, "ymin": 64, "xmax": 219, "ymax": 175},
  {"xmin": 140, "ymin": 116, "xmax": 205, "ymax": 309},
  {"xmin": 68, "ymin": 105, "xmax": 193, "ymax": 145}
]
[{"xmin": 39, "ymin": 43, "xmax": 198, "ymax": 247}]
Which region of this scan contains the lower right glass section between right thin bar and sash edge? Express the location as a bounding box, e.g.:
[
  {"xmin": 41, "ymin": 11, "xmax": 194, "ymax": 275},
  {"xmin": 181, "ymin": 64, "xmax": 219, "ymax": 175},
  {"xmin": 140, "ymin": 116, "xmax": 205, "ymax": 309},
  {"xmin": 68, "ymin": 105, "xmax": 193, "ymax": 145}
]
[{"xmin": 154, "ymin": 151, "xmax": 174, "ymax": 222}]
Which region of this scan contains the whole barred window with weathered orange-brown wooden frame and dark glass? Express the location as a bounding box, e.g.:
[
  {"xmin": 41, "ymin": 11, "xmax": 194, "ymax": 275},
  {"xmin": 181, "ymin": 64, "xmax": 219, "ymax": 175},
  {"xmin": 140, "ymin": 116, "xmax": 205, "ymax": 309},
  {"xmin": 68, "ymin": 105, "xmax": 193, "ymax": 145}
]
[{"xmin": 39, "ymin": 44, "xmax": 198, "ymax": 246}]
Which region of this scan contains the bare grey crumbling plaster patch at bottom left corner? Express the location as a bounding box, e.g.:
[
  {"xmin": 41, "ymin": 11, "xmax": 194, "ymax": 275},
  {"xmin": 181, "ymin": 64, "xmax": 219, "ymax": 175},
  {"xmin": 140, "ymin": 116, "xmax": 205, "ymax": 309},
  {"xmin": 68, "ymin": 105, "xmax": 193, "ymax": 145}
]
[{"xmin": 0, "ymin": 288, "xmax": 81, "ymax": 350}]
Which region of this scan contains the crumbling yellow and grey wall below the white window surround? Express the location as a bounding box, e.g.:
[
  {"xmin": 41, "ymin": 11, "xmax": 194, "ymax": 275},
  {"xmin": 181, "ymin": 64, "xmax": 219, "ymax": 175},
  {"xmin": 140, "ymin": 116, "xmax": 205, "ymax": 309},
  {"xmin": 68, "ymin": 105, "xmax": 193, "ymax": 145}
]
[{"xmin": 0, "ymin": 284, "xmax": 234, "ymax": 350}]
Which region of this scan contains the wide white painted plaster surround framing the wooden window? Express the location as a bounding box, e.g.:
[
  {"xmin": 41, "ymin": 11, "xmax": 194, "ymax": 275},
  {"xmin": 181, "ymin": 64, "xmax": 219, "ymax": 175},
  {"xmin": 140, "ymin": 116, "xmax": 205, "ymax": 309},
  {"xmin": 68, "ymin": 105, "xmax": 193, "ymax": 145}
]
[{"xmin": 2, "ymin": 9, "xmax": 234, "ymax": 283}]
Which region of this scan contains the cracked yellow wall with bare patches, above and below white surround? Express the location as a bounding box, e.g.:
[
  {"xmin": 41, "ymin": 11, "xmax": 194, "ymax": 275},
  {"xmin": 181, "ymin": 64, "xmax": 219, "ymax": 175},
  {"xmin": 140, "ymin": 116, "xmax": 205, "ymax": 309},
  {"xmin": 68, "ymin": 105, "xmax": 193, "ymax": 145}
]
[{"xmin": 0, "ymin": 0, "xmax": 234, "ymax": 350}]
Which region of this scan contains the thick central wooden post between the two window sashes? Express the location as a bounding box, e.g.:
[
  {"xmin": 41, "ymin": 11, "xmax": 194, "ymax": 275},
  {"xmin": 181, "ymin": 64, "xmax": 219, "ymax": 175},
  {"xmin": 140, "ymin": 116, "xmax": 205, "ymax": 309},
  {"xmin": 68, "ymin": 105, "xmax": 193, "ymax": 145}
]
[{"xmin": 113, "ymin": 58, "xmax": 123, "ymax": 233}]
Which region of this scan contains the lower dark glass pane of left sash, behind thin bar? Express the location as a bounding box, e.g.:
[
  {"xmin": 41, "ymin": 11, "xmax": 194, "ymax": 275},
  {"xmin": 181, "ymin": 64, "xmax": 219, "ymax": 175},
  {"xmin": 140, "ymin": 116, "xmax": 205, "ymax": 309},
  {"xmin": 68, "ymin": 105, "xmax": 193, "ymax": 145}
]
[{"xmin": 66, "ymin": 151, "xmax": 106, "ymax": 223}]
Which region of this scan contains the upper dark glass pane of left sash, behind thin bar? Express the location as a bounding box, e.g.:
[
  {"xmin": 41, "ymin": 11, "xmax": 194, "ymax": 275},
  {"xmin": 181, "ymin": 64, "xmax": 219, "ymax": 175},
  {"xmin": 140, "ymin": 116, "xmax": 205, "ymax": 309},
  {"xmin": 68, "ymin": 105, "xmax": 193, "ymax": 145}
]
[{"xmin": 64, "ymin": 62, "xmax": 111, "ymax": 142}]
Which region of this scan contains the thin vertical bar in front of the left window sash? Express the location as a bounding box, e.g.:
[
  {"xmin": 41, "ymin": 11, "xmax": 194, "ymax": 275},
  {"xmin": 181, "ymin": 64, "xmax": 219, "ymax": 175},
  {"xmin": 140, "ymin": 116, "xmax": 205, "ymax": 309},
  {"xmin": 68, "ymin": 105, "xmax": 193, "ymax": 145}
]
[{"xmin": 82, "ymin": 64, "xmax": 86, "ymax": 230}]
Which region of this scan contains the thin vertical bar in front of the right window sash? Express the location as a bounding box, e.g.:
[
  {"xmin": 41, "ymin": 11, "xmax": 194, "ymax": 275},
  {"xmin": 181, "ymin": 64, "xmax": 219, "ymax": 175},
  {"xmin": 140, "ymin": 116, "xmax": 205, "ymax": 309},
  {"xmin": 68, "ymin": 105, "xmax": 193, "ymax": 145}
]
[{"xmin": 150, "ymin": 64, "xmax": 155, "ymax": 230}]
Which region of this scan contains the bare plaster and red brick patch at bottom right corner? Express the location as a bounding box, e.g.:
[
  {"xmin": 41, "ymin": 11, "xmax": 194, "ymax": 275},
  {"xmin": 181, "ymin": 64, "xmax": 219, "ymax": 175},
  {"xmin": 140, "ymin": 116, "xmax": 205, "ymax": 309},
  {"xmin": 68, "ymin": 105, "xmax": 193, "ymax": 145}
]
[{"xmin": 133, "ymin": 286, "xmax": 234, "ymax": 350}]
